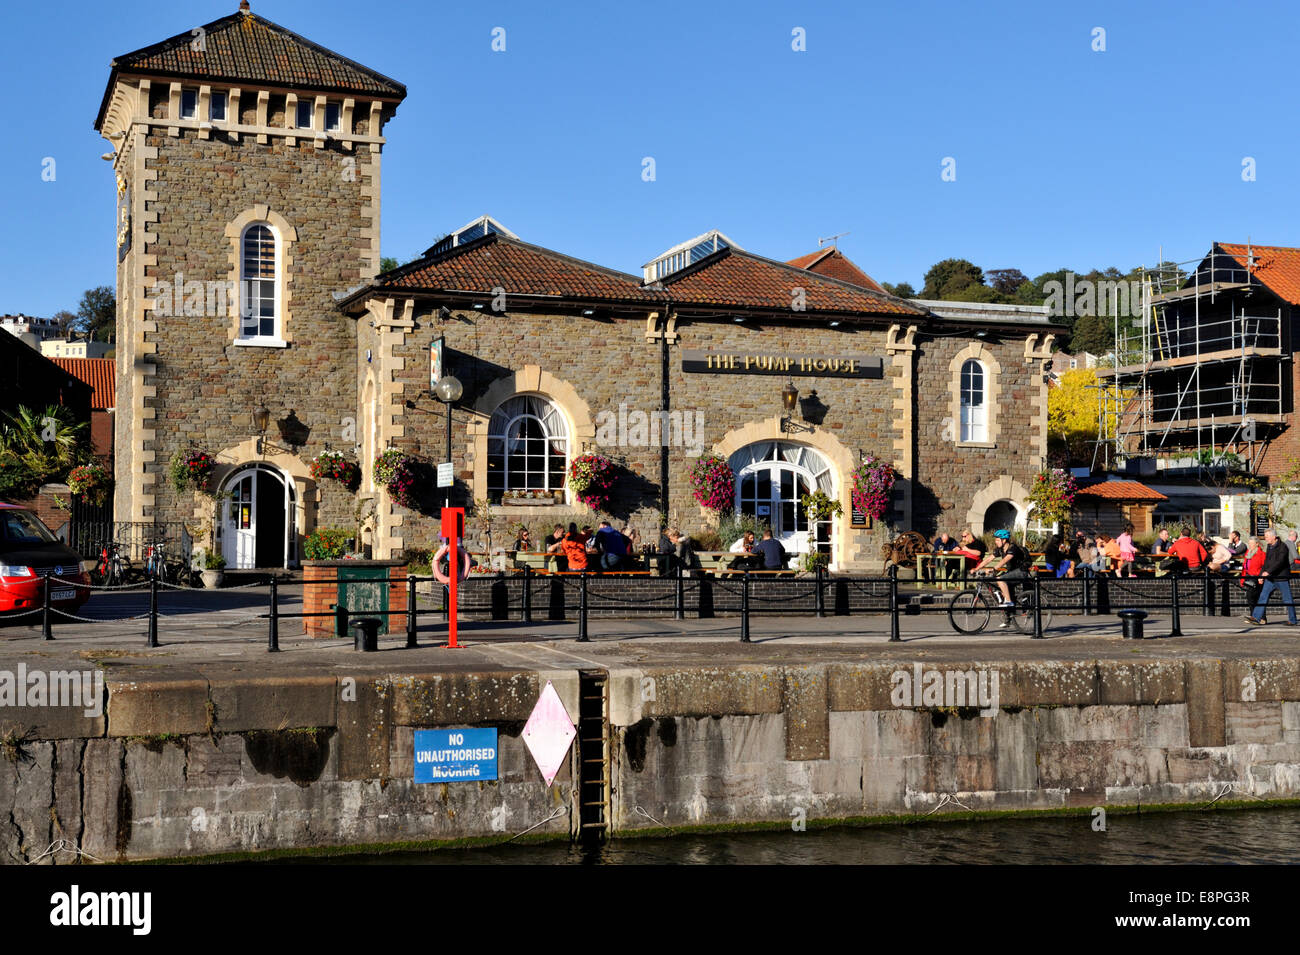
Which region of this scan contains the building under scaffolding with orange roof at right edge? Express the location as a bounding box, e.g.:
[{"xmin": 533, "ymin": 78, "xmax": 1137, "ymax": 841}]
[{"xmin": 1093, "ymin": 243, "xmax": 1300, "ymax": 477}]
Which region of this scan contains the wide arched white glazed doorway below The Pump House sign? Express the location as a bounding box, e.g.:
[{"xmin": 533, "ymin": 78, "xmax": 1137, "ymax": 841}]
[{"xmin": 728, "ymin": 440, "xmax": 836, "ymax": 554}]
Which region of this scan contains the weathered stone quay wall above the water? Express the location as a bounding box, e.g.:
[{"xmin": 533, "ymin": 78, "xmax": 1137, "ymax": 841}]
[{"xmin": 0, "ymin": 657, "xmax": 1300, "ymax": 863}]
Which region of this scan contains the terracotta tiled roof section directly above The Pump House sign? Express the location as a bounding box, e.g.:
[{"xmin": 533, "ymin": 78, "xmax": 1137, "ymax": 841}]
[{"xmin": 663, "ymin": 248, "xmax": 926, "ymax": 316}]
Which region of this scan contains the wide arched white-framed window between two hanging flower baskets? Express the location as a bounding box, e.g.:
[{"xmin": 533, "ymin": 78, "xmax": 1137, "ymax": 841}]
[{"xmin": 488, "ymin": 395, "xmax": 568, "ymax": 504}]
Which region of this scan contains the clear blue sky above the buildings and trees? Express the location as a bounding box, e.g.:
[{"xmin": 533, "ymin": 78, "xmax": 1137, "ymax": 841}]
[{"xmin": 0, "ymin": 0, "xmax": 1300, "ymax": 316}]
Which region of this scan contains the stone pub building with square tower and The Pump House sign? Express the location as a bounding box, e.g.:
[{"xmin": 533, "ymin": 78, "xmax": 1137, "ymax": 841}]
[{"xmin": 96, "ymin": 3, "xmax": 1054, "ymax": 569}]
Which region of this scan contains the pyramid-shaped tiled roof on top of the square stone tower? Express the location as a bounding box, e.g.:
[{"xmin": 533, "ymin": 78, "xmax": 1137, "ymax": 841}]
[{"xmin": 99, "ymin": 7, "xmax": 406, "ymax": 107}]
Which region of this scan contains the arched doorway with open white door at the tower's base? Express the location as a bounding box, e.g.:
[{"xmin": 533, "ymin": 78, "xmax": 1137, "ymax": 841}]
[{"xmin": 221, "ymin": 463, "xmax": 298, "ymax": 570}]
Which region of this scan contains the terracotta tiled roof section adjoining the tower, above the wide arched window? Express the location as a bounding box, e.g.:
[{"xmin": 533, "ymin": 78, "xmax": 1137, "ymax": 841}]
[{"xmin": 376, "ymin": 233, "xmax": 662, "ymax": 303}]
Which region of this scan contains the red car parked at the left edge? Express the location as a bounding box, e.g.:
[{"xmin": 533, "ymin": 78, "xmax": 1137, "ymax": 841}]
[{"xmin": 0, "ymin": 503, "xmax": 92, "ymax": 621}]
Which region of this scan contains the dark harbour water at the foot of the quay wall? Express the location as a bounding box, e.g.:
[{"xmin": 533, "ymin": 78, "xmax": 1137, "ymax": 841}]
[{"xmin": 294, "ymin": 808, "xmax": 1300, "ymax": 865}]
